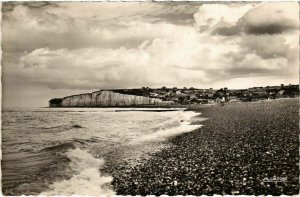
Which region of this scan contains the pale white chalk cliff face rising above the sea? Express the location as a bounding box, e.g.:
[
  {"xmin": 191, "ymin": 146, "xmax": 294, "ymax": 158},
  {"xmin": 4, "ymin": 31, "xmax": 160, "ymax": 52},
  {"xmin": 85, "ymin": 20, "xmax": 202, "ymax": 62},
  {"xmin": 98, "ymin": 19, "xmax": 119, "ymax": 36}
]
[{"xmin": 62, "ymin": 91, "xmax": 170, "ymax": 107}]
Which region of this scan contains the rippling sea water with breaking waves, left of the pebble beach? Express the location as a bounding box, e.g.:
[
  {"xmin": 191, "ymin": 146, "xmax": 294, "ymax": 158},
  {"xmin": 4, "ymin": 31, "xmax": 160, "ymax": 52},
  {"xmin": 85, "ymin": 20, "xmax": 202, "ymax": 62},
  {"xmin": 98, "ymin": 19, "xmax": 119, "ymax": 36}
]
[{"xmin": 1, "ymin": 108, "xmax": 201, "ymax": 195}]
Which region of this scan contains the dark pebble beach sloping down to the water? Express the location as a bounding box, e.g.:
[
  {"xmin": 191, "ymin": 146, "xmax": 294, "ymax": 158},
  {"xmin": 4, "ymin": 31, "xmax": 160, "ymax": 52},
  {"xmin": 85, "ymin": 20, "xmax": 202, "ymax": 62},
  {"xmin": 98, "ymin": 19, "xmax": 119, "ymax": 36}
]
[{"xmin": 113, "ymin": 99, "xmax": 299, "ymax": 195}]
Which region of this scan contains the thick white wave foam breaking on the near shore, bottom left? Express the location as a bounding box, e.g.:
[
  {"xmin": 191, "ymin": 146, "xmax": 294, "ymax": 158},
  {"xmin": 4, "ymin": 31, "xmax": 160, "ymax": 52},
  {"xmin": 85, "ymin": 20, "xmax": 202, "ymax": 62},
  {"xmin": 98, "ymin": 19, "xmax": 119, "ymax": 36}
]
[{"xmin": 41, "ymin": 148, "xmax": 115, "ymax": 196}]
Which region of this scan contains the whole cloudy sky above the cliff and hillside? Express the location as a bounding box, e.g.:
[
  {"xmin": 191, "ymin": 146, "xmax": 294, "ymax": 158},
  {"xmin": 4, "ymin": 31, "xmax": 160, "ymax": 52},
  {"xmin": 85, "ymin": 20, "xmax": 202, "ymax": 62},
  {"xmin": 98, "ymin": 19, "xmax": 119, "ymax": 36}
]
[{"xmin": 2, "ymin": 2, "xmax": 299, "ymax": 107}]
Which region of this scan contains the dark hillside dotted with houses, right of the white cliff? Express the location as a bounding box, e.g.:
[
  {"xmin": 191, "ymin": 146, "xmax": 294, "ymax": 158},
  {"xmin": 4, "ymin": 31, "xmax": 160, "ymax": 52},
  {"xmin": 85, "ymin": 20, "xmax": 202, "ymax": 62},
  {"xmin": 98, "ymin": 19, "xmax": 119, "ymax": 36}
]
[{"xmin": 113, "ymin": 84, "xmax": 299, "ymax": 105}]
